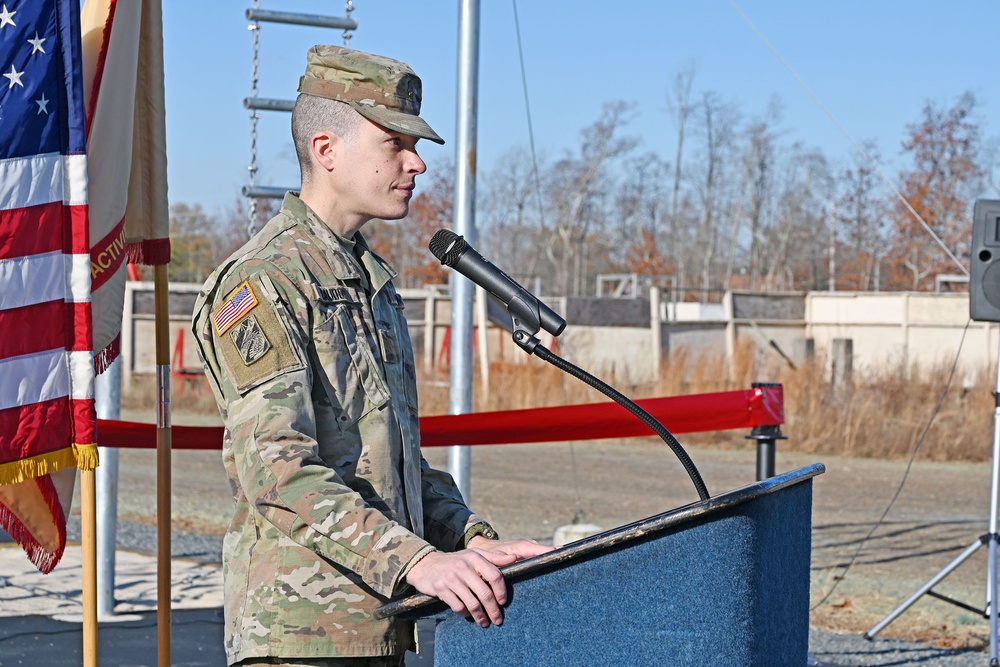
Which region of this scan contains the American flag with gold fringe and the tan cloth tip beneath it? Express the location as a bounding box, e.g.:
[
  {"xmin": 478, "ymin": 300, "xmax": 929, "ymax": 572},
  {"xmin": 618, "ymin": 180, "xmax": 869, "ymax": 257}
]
[{"xmin": 0, "ymin": 0, "xmax": 96, "ymax": 572}]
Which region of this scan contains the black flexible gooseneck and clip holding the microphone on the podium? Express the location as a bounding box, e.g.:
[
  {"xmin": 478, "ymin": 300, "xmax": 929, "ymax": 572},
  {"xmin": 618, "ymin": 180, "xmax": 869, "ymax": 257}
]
[{"xmin": 508, "ymin": 309, "xmax": 709, "ymax": 500}]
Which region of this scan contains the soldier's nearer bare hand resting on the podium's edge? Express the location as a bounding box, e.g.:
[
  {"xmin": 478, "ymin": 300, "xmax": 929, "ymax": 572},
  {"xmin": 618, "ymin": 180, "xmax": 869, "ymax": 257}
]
[{"xmin": 406, "ymin": 549, "xmax": 517, "ymax": 628}]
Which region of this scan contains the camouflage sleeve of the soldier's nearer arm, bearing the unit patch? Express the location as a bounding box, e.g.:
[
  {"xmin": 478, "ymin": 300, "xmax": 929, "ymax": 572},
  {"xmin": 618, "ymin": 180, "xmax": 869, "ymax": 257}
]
[{"xmin": 207, "ymin": 266, "xmax": 433, "ymax": 596}]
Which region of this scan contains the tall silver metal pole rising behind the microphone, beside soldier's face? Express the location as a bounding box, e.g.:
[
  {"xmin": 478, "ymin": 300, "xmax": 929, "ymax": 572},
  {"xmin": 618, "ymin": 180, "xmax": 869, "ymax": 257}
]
[{"xmin": 448, "ymin": 0, "xmax": 479, "ymax": 500}]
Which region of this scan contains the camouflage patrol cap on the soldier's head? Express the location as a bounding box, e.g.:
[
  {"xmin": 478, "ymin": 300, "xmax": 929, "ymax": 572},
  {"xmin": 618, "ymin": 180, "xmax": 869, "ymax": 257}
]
[{"xmin": 299, "ymin": 44, "xmax": 444, "ymax": 144}]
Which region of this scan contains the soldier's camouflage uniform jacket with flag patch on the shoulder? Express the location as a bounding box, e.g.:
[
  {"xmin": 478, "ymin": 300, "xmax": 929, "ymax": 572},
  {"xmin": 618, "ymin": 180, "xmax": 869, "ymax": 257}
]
[{"xmin": 193, "ymin": 194, "xmax": 488, "ymax": 663}]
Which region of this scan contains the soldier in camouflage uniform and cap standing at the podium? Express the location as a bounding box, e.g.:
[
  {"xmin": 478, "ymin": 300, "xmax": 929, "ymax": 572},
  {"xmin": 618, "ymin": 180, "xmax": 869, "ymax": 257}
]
[{"xmin": 193, "ymin": 46, "xmax": 550, "ymax": 666}]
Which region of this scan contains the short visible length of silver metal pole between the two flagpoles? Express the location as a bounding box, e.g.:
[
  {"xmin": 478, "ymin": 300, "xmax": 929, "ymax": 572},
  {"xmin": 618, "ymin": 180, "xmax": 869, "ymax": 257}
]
[{"xmin": 94, "ymin": 357, "xmax": 122, "ymax": 619}]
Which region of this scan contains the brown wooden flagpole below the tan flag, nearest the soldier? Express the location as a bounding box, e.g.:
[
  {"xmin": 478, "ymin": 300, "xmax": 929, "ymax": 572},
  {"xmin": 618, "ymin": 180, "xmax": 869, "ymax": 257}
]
[{"xmin": 153, "ymin": 264, "xmax": 171, "ymax": 667}]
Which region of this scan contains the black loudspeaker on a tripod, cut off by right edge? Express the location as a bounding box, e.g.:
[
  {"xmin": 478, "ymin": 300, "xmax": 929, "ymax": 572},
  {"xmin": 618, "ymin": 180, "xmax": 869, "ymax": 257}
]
[{"xmin": 969, "ymin": 199, "xmax": 1000, "ymax": 322}]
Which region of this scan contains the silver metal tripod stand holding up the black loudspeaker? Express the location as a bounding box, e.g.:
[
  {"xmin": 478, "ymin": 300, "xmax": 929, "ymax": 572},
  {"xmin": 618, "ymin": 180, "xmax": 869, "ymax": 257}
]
[{"xmin": 864, "ymin": 340, "xmax": 1000, "ymax": 667}]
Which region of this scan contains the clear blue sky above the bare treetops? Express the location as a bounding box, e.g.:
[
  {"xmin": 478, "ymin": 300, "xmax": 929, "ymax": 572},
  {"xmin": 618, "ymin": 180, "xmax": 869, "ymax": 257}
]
[{"xmin": 163, "ymin": 0, "xmax": 1000, "ymax": 218}]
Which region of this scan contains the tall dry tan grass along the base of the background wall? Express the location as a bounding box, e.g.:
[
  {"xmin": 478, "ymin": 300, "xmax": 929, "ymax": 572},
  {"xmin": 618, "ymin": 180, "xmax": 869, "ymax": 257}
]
[{"xmin": 131, "ymin": 345, "xmax": 995, "ymax": 461}]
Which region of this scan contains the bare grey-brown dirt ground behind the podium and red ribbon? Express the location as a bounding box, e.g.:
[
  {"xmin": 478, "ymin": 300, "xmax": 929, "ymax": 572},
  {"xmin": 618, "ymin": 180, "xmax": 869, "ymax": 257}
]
[{"xmin": 113, "ymin": 408, "xmax": 991, "ymax": 647}]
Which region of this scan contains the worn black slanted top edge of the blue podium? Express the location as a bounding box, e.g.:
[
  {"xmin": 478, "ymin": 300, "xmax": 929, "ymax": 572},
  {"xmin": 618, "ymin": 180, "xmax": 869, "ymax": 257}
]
[{"xmin": 375, "ymin": 463, "xmax": 826, "ymax": 618}]
